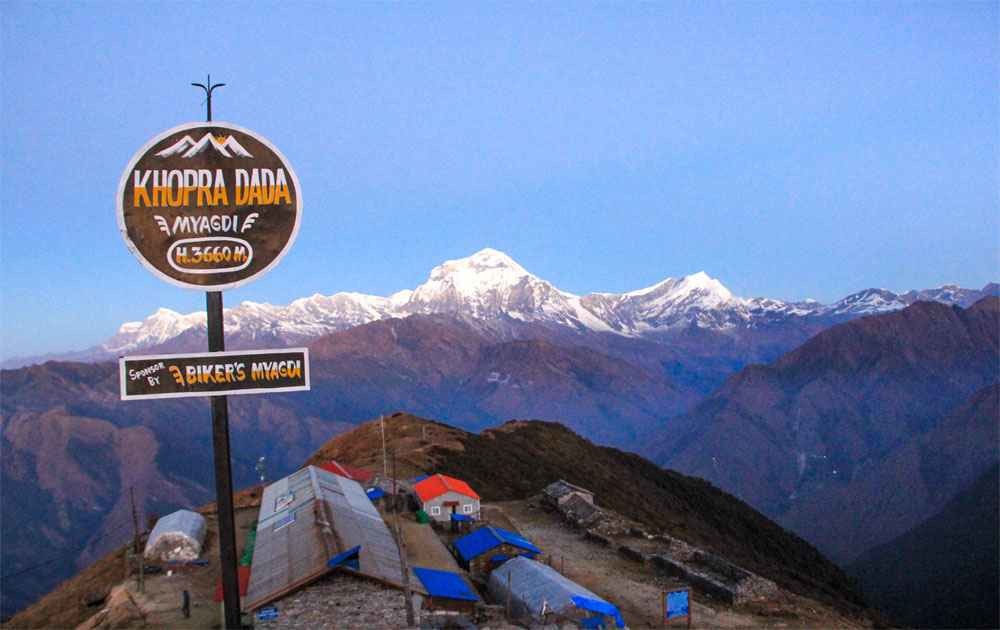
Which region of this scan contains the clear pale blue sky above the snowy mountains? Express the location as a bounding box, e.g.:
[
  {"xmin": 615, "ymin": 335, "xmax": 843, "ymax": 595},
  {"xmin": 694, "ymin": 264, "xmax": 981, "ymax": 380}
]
[{"xmin": 0, "ymin": 2, "xmax": 1000, "ymax": 357}]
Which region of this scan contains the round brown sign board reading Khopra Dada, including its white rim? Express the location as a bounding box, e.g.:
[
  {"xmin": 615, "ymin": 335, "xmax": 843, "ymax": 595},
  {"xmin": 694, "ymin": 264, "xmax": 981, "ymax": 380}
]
[{"xmin": 117, "ymin": 122, "xmax": 302, "ymax": 291}]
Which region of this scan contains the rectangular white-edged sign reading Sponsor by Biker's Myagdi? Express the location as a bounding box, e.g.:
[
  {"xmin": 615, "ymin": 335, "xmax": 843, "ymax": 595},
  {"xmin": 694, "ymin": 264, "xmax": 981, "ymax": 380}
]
[{"xmin": 118, "ymin": 348, "xmax": 309, "ymax": 400}]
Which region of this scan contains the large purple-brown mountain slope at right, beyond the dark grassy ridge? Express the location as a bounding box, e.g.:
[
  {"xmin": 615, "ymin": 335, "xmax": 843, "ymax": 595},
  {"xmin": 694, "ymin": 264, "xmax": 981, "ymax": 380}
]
[{"xmin": 648, "ymin": 298, "xmax": 1000, "ymax": 561}]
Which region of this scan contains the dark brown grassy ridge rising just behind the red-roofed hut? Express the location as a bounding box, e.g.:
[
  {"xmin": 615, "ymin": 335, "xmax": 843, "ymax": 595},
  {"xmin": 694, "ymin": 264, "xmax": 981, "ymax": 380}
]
[{"xmin": 310, "ymin": 413, "xmax": 863, "ymax": 612}]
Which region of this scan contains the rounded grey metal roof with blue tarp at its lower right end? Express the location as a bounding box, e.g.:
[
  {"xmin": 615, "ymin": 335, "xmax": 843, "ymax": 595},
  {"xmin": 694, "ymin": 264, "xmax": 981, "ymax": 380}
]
[{"xmin": 487, "ymin": 556, "xmax": 624, "ymax": 627}]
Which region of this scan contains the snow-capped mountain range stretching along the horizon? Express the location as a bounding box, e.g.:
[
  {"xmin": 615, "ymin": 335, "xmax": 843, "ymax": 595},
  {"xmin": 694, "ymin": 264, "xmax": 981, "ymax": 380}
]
[{"xmin": 4, "ymin": 249, "xmax": 1000, "ymax": 372}]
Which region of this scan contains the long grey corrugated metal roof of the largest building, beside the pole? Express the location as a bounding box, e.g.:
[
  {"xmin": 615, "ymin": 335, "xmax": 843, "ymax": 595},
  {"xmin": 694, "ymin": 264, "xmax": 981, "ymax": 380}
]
[{"xmin": 243, "ymin": 466, "xmax": 426, "ymax": 610}]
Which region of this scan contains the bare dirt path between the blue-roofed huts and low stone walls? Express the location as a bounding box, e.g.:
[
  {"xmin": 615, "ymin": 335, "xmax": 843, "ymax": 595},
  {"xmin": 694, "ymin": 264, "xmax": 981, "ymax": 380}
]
[{"xmin": 494, "ymin": 501, "xmax": 857, "ymax": 628}]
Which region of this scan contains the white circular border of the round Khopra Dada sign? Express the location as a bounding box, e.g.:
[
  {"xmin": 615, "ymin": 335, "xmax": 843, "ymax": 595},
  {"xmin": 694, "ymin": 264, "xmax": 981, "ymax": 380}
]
[{"xmin": 115, "ymin": 120, "xmax": 302, "ymax": 291}]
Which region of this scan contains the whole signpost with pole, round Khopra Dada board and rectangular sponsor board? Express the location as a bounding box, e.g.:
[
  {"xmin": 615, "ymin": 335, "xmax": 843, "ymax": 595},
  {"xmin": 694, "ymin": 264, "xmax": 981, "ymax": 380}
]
[{"xmin": 117, "ymin": 76, "xmax": 300, "ymax": 630}]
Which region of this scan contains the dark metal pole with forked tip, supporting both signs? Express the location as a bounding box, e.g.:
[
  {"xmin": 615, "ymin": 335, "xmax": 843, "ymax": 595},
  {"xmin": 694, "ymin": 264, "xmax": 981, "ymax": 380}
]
[{"xmin": 191, "ymin": 75, "xmax": 242, "ymax": 630}]
